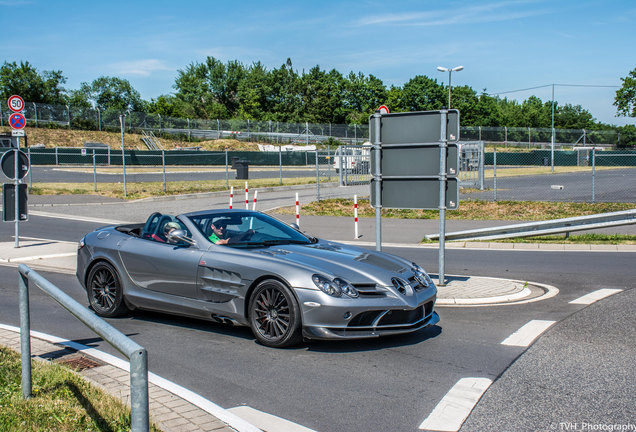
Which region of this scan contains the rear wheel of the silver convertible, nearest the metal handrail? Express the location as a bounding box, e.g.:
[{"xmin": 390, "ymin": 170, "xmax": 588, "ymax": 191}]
[{"xmin": 86, "ymin": 262, "xmax": 129, "ymax": 318}]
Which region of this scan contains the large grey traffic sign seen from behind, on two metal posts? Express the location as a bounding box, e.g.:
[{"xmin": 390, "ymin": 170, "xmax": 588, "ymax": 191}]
[{"xmin": 369, "ymin": 109, "xmax": 459, "ymax": 286}]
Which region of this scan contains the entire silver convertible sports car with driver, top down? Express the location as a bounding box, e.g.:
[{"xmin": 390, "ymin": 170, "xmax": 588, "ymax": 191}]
[{"xmin": 77, "ymin": 210, "xmax": 439, "ymax": 347}]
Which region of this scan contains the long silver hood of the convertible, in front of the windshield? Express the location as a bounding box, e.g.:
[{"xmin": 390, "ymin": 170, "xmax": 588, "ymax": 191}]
[{"xmin": 255, "ymin": 240, "xmax": 411, "ymax": 285}]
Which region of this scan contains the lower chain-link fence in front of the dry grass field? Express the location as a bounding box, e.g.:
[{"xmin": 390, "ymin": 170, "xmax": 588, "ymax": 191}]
[{"xmin": 2, "ymin": 142, "xmax": 636, "ymax": 203}]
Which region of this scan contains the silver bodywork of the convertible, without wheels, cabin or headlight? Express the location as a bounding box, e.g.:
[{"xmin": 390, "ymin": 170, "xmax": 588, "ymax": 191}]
[{"xmin": 77, "ymin": 210, "xmax": 439, "ymax": 339}]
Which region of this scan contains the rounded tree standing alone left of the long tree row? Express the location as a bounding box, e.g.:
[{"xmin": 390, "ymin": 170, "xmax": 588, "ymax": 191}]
[{"xmin": 76, "ymin": 76, "xmax": 147, "ymax": 112}]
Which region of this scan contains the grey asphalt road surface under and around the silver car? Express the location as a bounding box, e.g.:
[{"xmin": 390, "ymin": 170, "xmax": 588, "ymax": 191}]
[{"xmin": 0, "ymin": 211, "xmax": 636, "ymax": 432}]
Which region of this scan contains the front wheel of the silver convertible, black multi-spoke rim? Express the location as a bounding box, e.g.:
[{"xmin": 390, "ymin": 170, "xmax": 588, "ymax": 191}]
[{"xmin": 249, "ymin": 279, "xmax": 302, "ymax": 348}]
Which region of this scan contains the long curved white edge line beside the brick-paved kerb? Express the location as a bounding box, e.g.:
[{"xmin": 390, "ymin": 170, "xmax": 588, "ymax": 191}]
[{"xmin": 0, "ymin": 324, "xmax": 261, "ymax": 432}]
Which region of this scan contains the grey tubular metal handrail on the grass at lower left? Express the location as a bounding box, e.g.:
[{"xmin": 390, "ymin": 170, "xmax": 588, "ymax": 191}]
[{"xmin": 18, "ymin": 264, "xmax": 150, "ymax": 432}]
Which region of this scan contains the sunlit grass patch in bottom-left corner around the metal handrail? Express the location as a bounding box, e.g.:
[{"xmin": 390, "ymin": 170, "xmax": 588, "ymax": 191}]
[{"xmin": 0, "ymin": 346, "xmax": 158, "ymax": 432}]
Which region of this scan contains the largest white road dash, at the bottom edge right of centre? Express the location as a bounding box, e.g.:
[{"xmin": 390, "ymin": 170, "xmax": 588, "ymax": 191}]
[{"xmin": 420, "ymin": 378, "xmax": 492, "ymax": 432}]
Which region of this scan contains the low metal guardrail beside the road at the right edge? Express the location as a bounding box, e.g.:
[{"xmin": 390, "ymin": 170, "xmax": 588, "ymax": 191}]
[{"xmin": 425, "ymin": 209, "xmax": 636, "ymax": 240}]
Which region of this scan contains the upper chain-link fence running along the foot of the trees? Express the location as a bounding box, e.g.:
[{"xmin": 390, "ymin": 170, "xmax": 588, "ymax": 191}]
[{"xmin": 0, "ymin": 102, "xmax": 636, "ymax": 149}]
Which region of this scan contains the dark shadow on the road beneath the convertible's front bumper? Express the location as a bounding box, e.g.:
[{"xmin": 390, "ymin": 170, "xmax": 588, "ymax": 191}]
[{"xmin": 306, "ymin": 325, "xmax": 442, "ymax": 353}]
